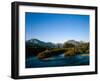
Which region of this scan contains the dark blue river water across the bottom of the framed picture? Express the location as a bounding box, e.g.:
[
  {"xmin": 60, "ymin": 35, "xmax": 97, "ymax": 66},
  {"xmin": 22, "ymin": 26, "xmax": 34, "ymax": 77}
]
[{"xmin": 26, "ymin": 54, "xmax": 89, "ymax": 68}]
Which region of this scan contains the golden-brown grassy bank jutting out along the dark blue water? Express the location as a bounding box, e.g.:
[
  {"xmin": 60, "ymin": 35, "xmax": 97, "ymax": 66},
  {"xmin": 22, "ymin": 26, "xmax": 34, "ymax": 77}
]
[{"xmin": 37, "ymin": 48, "xmax": 89, "ymax": 59}]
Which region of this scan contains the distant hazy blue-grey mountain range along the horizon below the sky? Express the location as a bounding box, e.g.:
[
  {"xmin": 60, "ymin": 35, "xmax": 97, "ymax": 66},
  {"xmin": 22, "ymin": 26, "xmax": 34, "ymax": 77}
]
[{"xmin": 26, "ymin": 39, "xmax": 84, "ymax": 48}]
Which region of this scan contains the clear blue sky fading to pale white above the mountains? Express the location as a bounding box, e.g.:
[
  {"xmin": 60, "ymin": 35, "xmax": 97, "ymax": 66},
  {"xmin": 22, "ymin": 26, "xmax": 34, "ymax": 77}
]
[{"xmin": 25, "ymin": 12, "xmax": 90, "ymax": 43}]
